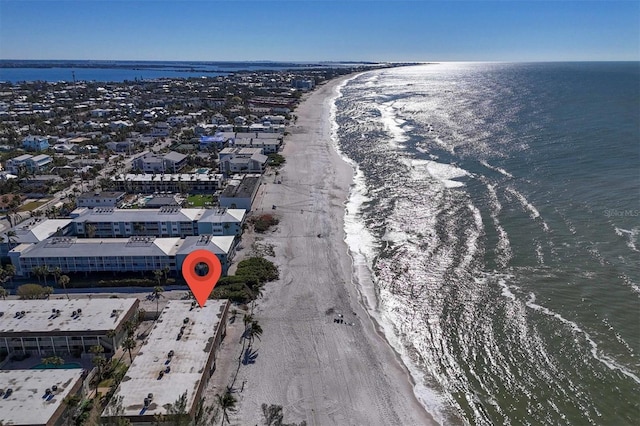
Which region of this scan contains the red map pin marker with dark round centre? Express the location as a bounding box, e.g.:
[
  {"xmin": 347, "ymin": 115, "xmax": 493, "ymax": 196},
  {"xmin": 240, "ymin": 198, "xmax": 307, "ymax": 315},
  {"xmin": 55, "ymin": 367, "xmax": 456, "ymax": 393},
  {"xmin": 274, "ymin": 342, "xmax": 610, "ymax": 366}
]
[{"xmin": 182, "ymin": 250, "xmax": 222, "ymax": 308}]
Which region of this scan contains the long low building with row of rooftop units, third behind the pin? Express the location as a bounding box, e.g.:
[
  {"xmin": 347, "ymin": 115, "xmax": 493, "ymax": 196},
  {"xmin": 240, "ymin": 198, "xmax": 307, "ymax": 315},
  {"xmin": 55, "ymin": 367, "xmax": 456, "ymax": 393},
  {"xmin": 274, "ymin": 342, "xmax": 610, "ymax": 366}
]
[{"xmin": 111, "ymin": 173, "xmax": 225, "ymax": 194}]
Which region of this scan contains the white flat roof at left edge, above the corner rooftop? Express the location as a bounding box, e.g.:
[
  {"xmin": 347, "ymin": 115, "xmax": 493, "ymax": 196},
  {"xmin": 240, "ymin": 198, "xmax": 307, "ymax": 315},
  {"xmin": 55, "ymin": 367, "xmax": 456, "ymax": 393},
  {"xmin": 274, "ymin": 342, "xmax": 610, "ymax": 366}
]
[{"xmin": 0, "ymin": 299, "xmax": 138, "ymax": 336}]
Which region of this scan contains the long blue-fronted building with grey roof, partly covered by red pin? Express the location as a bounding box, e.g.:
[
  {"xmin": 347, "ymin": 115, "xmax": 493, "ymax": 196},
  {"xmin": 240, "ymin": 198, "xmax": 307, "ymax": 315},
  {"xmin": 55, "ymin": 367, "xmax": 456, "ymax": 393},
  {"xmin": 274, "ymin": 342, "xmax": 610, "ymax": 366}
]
[{"xmin": 9, "ymin": 235, "xmax": 236, "ymax": 277}]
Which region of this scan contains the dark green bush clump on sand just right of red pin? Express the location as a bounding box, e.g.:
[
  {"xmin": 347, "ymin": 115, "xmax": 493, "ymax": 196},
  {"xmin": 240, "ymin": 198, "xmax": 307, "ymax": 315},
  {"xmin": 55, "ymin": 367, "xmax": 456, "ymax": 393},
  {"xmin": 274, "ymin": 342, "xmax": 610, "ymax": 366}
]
[{"xmin": 210, "ymin": 257, "xmax": 279, "ymax": 303}]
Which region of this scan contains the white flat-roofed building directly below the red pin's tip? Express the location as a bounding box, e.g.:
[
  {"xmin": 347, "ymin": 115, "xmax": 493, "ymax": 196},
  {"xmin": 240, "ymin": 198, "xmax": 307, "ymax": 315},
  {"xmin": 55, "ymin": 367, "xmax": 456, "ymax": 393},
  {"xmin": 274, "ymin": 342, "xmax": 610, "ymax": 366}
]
[{"xmin": 102, "ymin": 300, "xmax": 230, "ymax": 425}]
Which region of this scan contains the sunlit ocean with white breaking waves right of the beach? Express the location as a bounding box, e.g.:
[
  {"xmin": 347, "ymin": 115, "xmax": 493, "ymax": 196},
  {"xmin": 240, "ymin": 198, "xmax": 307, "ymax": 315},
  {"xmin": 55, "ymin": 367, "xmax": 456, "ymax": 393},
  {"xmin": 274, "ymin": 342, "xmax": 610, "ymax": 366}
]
[{"xmin": 332, "ymin": 62, "xmax": 640, "ymax": 425}]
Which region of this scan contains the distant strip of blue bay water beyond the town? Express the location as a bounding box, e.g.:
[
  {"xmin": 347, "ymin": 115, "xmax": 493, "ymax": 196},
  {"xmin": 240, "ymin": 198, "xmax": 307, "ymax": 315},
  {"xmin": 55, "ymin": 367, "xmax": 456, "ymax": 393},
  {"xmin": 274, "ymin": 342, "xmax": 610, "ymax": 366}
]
[{"xmin": 0, "ymin": 60, "xmax": 360, "ymax": 83}]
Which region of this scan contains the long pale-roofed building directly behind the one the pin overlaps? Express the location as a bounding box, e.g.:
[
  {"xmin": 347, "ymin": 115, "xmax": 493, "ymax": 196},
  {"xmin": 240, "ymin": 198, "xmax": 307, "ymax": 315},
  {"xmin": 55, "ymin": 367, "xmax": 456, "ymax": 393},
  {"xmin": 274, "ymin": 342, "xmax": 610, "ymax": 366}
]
[{"xmin": 71, "ymin": 206, "xmax": 246, "ymax": 238}]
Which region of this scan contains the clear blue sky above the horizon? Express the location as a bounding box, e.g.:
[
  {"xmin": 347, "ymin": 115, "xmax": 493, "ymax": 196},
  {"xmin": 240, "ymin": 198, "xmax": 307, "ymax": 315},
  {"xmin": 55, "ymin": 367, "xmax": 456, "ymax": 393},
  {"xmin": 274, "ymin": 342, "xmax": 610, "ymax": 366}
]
[{"xmin": 0, "ymin": 0, "xmax": 640, "ymax": 61}]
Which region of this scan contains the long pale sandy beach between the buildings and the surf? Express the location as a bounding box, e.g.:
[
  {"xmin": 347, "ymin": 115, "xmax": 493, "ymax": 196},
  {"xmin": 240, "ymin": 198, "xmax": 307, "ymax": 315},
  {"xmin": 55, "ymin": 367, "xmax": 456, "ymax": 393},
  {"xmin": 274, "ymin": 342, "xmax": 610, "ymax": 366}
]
[{"xmin": 225, "ymin": 79, "xmax": 433, "ymax": 425}]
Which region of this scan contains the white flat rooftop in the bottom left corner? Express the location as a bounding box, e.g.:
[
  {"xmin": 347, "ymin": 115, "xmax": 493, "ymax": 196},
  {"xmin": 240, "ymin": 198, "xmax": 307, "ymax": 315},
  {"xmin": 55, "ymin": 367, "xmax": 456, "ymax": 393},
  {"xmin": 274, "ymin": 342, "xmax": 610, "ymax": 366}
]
[{"xmin": 0, "ymin": 368, "xmax": 82, "ymax": 426}]
